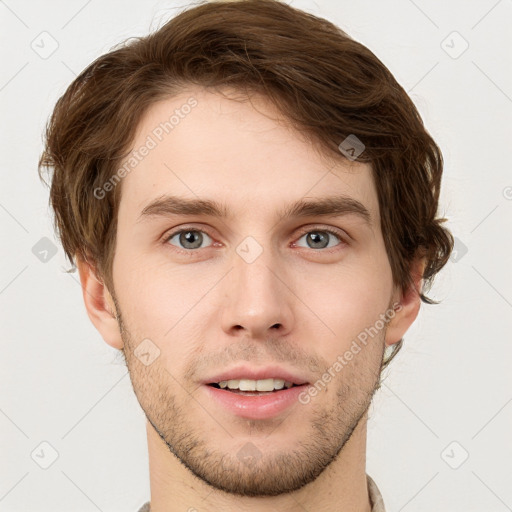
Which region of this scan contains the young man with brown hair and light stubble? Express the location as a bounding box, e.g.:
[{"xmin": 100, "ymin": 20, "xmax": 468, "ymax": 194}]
[{"xmin": 40, "ymin": 0, "xmax": 453, "ymax": 512}]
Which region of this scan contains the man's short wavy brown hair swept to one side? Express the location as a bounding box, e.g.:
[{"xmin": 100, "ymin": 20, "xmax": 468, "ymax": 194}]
[{"xmin": 39, "ymin": 0, "xmax": 453, "ymax": 364}]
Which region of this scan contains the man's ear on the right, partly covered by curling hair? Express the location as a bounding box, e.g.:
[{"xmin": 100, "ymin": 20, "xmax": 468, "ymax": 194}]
[{"xmin": 385, "ymin": 254, "xmax": 426, "ymax": 346}]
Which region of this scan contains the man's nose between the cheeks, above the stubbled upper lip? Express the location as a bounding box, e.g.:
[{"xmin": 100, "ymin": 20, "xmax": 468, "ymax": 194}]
[{"xmin": 222, "ymin": 244, "xmax": 294, "ymax": 339}]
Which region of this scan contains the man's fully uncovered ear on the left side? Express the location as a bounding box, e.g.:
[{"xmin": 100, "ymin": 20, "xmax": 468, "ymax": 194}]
[{"xmin": 77, "ymin": 258, "xmax": 123, "ymax": 349}]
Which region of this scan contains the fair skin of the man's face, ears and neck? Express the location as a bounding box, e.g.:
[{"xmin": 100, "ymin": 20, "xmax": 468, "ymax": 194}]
[{"xmin": 78, "ymin": 88, "xmax": 424, "ymax": 512}]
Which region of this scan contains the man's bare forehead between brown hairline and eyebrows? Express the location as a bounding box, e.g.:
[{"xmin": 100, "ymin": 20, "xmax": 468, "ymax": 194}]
[{"xmin": 120, "ymin": 88, "xmax": 378, "ymax": 222}]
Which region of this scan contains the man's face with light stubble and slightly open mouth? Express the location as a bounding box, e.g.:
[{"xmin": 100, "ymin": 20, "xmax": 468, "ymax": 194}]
[{"xmin": 107, "ymin": 89, "xmax": 394, "ymax": 496}]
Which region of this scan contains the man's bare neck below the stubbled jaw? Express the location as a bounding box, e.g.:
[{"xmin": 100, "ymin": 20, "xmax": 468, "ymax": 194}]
[{"xmin": 146, "ymin": 413, "xmax": 371, "ymax": 512}]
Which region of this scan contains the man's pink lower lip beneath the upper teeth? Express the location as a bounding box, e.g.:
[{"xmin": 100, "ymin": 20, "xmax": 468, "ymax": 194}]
[{"xmin": 204, "ymin": 384, "xmax": 308, "ymax": 420}]
